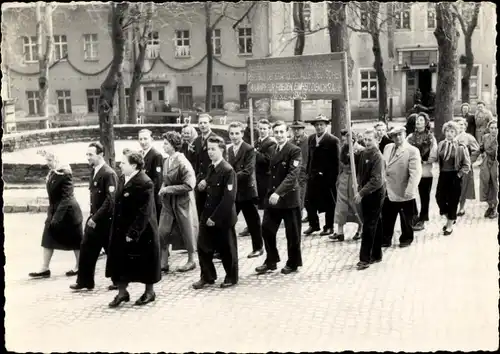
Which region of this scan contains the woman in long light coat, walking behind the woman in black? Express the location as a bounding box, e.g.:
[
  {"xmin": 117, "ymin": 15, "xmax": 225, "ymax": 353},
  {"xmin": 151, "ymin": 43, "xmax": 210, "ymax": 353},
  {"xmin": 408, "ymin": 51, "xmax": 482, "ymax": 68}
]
[{"xmin": 159, "ymin": 131, "xmax": 198, "ymax": 272}]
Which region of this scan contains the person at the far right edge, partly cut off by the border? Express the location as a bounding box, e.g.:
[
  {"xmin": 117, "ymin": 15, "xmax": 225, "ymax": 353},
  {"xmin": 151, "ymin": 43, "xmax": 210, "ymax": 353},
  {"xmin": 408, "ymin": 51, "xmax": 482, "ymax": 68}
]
[{"xmin": 479, "ymin": 120, "xmax": 498, "ymax": 219}]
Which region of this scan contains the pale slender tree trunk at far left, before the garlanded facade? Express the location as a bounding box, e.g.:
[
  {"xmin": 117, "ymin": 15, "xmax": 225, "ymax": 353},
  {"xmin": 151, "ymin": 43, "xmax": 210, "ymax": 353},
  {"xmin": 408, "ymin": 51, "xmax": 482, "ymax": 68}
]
[{"xmin": 36, "ymin": 2, "xmax": 54, "ymax": 128}]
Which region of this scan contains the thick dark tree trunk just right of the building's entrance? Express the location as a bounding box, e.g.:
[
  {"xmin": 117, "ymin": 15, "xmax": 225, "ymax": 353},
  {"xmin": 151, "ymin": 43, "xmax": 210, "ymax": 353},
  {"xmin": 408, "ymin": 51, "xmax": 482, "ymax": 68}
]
[{"xmin": 434, "ymin": 2, "xmax": 460, "ymax": 141}]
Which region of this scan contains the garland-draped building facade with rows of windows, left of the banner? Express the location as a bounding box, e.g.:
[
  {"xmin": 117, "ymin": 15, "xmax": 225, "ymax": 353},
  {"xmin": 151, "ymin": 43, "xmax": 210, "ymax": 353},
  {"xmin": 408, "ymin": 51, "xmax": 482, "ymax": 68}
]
[{"xmin": 2, "ymin": 3, "xmax": 269, "ymax": 124}]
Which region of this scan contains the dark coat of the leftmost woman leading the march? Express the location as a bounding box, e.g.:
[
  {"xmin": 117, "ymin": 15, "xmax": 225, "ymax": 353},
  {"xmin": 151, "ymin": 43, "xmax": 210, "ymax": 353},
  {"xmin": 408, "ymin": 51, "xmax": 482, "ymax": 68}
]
[{"xmin": 42, "ymin": 166, "xmax": 83, "ymax": 250}]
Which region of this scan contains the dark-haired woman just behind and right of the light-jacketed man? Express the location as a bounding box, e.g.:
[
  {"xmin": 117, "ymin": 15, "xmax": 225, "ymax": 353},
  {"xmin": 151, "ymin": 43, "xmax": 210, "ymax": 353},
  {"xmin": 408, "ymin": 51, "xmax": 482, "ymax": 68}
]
[{"xmin": 407, "ymin": 113, "xmax": 437, "ymax": 231}]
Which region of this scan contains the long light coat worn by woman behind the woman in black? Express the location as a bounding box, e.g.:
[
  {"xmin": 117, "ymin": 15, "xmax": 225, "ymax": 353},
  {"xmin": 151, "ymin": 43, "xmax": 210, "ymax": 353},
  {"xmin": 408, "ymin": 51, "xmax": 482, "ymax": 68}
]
[{"xmin": 159, "ymin": 153, "xmax": 198, "ymax": 252}]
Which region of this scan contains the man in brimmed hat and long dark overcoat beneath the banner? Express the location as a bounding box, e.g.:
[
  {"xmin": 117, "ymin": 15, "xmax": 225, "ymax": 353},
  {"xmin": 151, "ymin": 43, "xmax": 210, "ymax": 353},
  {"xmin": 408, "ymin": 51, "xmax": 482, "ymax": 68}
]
[{"xmin": 304, "ymin": 115, "xmax": 340, "ymax": 236}]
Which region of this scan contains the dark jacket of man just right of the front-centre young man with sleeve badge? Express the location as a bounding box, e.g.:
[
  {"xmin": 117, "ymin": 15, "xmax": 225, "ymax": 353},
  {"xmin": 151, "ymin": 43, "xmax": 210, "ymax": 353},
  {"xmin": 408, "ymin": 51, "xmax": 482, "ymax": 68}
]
[{"xmin": 227, "ymin": 141, "xmax": 258, "ymax": 202}]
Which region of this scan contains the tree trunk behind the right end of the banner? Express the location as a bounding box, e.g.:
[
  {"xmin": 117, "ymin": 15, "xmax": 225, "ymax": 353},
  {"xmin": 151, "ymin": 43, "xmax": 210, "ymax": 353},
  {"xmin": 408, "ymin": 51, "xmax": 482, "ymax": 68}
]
[{"xmin": 328, "ymin": 1, "xmax": 354, "ymax": 137}]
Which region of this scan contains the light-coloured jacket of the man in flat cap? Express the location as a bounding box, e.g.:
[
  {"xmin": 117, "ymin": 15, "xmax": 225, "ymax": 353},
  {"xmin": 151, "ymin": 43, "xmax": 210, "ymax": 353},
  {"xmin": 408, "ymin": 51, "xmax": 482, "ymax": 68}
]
[{"xmin": 384, "ymin": 141, "xmax": 422, "ymax": 202}]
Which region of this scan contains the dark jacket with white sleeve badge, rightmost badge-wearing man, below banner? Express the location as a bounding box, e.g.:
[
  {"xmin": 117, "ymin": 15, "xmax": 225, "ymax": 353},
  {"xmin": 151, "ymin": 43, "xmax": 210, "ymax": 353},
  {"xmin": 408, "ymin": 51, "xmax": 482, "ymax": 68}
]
[{"xmin": 265, "ymin": 142, "xmax": 302, "ymax": 209}]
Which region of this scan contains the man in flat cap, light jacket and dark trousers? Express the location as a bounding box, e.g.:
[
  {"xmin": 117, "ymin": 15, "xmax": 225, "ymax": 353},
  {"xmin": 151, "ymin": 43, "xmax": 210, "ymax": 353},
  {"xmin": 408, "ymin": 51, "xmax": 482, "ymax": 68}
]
[{"xmin": 382, "ymin": 127, "xmax": 422, "ymax": 247}]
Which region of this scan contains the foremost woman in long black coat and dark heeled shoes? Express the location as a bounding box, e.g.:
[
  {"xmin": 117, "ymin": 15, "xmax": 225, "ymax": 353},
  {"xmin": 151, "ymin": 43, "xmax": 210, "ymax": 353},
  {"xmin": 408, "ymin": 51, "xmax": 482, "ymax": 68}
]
[{"xmin": 106, "ymin": 151, "xmax": 161, "ymax": 307}]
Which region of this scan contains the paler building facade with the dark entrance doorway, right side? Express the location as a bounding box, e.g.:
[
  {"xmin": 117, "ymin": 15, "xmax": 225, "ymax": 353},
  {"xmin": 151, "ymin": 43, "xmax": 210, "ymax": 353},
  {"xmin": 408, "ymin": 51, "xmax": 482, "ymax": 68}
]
[{"xmin": 269, "ymin": 2, "xmax": 496, "ymax": 119}]
